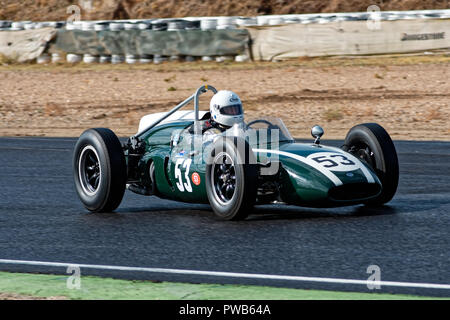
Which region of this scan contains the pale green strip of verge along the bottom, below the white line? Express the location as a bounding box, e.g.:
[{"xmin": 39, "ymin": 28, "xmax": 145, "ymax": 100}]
[{"xmin": 0, "ymin": 272, "xmax": 444, "ymax": 300}]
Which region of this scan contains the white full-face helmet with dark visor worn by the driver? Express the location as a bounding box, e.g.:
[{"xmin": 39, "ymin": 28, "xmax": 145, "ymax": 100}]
[{"xmin": 209, "ymin": 90, "xmax": 244, "ymax": 127}]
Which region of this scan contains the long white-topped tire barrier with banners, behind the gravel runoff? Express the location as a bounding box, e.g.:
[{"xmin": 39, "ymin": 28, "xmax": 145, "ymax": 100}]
[{"xmin": 0, "ymin": 10, "xmax": 450, "ymax": 64}]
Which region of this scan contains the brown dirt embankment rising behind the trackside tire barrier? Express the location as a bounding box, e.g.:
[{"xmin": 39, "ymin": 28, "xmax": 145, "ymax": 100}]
[{"xmin": 0, "ymin": 0, "xmax": 449, "ymax": 21}]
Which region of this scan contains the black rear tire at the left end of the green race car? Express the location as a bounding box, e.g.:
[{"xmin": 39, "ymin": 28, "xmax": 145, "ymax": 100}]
[{"xmin": 73, "ymin": 128, "xmax": 127, "ymax": 212}]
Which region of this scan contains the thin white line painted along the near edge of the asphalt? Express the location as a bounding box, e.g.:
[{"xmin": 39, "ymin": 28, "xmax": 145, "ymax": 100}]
[{"xmin": 0, "ymin": 259, "xmax": 450, "ymax": 290}]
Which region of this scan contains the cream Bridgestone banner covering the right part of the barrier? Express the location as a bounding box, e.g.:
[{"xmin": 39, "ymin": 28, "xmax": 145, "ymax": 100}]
[{"xmin": 248, "ymin": 19, "xmax": 450, "ymax": 61}]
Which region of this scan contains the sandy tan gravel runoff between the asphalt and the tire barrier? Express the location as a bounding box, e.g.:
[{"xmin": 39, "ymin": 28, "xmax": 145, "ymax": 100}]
[{"xmin": 0, "ymin": 54, "xmax": 450, "ymax": 140}]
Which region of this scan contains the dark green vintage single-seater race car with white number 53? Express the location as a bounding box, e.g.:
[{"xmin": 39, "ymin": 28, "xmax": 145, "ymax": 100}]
[{"xmin": 73, "ymin": 86, "xmax": 399, "ymax": 220}]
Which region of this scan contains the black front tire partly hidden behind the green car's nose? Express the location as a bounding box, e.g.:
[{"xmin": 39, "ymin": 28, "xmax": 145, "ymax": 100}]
[{"xmin": 342, "ymin": 123, "xmax": 399, "ymax": 206}]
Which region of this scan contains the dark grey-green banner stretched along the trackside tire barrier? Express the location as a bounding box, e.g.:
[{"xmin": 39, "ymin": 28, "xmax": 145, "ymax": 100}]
[{"xmin": 51, "ymin": 29, "xmax": 249, "ymax": 56}]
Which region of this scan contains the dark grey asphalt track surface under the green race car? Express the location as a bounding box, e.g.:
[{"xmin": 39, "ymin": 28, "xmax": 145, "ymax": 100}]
[{"xmin": 0, "ymin": 138, "xmax": 450, "ymax": 297}]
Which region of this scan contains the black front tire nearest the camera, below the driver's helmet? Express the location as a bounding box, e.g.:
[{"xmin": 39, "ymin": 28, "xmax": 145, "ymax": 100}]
[{"xmin": 206, "ymin": 137, "xmax": 258, "ymax": 220}]
